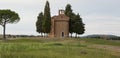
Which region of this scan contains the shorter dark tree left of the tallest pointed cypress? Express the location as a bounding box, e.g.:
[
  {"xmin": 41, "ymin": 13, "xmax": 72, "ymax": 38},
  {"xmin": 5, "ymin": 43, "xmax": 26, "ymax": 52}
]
[{"xmin": 36, "ymin": 12, "xmax": 44, "ymax": 35}]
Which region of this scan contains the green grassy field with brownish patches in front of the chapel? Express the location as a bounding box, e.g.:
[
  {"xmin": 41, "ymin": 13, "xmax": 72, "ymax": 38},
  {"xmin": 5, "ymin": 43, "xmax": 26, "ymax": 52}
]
[{"xmin": 0, "ymin": 38, "xmax": 120, "ymax": 58}]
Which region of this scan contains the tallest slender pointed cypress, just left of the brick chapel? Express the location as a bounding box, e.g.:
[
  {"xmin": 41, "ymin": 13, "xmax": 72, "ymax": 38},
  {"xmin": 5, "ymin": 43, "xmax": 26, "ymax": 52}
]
[{"xmin": 43, "ymin": 1, "xmax": 51, "ymax": 33}]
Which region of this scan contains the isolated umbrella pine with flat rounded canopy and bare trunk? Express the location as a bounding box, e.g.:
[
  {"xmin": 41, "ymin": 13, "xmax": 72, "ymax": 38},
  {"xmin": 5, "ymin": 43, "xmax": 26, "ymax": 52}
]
[{"xmin": 0, "ymin": 9, "xmax": 20, "ymax": 39}]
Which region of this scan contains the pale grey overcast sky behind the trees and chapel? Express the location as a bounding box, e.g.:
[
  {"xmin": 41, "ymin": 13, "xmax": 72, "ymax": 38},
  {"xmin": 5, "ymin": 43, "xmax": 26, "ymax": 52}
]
[{"xmin": 0, "ymin": 0, "xmax": 120, "ymax": 36}]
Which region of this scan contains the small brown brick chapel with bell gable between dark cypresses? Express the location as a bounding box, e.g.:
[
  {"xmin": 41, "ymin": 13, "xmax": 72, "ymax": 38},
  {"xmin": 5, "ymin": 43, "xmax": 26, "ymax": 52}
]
[{"xmin": 49, "ymin": 10, "xmax": 69, "ymax": 37}]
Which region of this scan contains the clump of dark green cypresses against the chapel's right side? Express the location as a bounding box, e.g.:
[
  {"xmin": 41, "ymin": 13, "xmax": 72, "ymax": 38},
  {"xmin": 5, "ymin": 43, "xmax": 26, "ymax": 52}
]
[{"xmin": 65, "ymin": 4, "xmax": 85, "ymax": 37}]
